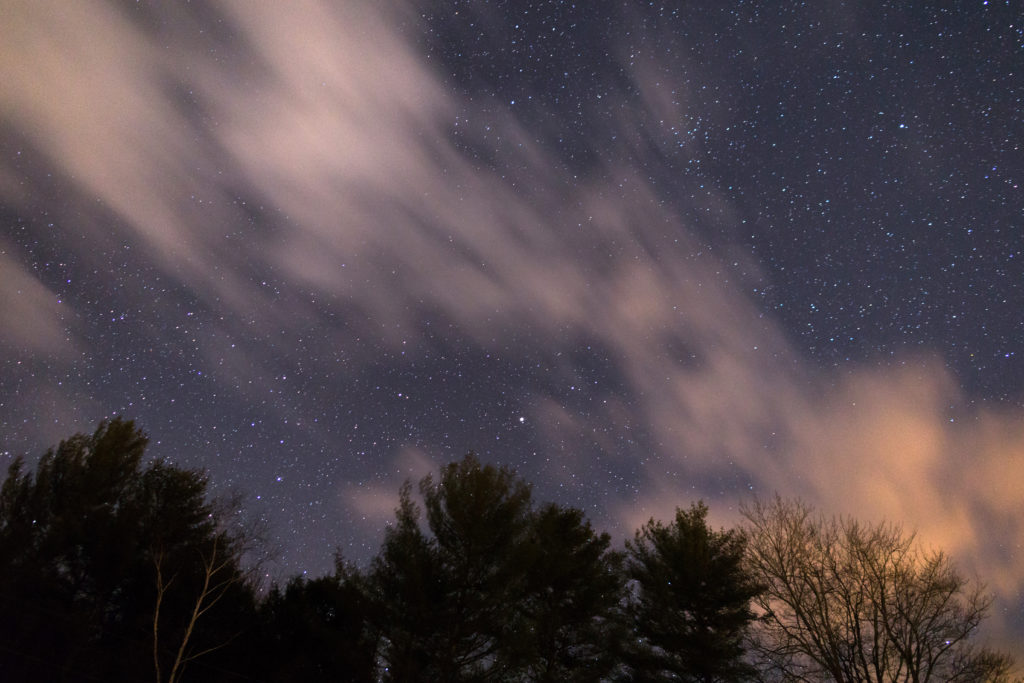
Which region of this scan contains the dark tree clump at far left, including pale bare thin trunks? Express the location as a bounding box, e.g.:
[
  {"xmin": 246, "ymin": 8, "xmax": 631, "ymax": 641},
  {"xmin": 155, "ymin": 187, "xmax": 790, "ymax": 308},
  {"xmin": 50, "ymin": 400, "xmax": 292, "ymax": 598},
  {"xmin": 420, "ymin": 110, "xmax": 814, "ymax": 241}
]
[{"xmin": 0, "ymin": 419, "xmax": 260, "ymax": 680}]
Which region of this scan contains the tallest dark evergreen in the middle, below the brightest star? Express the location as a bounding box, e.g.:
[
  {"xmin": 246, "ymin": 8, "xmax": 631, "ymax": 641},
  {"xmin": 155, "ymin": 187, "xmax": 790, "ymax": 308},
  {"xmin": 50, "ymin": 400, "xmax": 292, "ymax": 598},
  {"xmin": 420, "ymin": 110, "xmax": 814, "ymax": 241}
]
[{"xmin": 372, "ymin": 454, "xmax": 530, "ymax": 681}]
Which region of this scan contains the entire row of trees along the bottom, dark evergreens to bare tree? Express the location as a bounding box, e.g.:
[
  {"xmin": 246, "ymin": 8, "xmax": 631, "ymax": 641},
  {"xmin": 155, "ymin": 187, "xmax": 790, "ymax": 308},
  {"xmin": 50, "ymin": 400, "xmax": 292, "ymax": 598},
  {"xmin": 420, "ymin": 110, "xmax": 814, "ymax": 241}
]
[{"xmin": 0, "ymin": 418, "xmax": 1021, "ymax": 683}]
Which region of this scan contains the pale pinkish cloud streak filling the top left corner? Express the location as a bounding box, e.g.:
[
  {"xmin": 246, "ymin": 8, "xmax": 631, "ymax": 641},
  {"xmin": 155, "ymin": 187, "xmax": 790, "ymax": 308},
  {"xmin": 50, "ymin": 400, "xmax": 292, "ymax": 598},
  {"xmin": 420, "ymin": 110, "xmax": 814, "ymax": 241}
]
[{"xmin": 0, "ymin": 0, "xmax": 191, "ymax": 256}]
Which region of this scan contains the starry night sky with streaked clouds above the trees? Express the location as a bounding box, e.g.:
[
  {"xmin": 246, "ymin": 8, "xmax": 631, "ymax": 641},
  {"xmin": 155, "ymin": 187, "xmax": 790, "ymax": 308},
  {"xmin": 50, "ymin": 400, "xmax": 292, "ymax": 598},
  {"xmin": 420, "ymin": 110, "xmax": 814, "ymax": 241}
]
[{"xmin": 0, "ymin": 0, "xmax": 1024, "ymax": 651}]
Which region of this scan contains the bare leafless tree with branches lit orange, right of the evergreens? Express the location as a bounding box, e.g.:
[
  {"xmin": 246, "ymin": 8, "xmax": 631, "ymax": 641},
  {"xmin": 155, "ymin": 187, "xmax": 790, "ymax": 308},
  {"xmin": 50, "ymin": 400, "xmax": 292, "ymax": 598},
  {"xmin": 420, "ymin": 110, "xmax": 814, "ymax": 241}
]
[{"xmin": 743, "ymin": 497, "xmax": 1012, "ymax": 683}]
